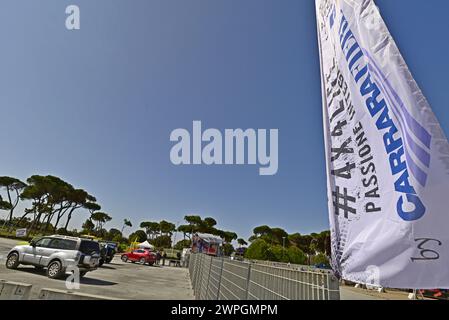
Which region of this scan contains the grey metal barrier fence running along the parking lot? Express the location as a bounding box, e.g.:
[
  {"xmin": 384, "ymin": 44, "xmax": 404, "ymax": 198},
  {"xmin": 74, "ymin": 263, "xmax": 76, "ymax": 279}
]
[{"xmin": 189, "ymin": 254, "xmax": 340, "ymax": 300}]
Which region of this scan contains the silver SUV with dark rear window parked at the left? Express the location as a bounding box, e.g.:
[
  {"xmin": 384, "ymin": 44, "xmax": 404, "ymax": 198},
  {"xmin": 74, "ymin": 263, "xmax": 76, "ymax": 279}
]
[{"xmin": 6, "ymin": 235, "xmax": 100, "ymax": 279}]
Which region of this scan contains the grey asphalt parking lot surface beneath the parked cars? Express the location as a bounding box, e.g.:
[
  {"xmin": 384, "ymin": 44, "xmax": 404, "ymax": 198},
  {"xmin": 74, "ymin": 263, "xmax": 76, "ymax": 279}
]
[{"xmin": 0, "ymin": 238, "xmax": 194, "ymax": 300}]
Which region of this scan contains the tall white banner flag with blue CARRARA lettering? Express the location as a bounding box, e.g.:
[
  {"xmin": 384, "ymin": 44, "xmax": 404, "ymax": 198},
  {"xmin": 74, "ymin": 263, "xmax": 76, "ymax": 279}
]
[{"xmin": 316, "ymin": 0, "xmax": 449, "ymax": 289}]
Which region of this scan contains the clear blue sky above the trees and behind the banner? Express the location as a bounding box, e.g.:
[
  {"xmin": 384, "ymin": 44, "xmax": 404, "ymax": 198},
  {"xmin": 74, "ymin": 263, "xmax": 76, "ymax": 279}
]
[{"xmin": 0, "ymin": 0, "xmax": 449, "ymax": 238}]
